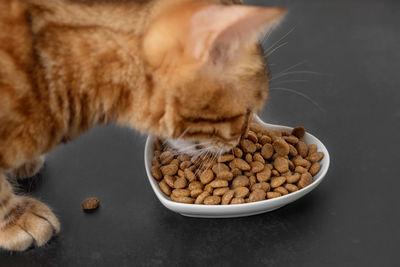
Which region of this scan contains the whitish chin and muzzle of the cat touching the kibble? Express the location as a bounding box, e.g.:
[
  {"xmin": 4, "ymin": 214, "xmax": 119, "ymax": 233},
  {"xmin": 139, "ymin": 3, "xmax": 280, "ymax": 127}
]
[{"xmin": 167, "ymin": 139, "xmax": 233, "ymax": 156}]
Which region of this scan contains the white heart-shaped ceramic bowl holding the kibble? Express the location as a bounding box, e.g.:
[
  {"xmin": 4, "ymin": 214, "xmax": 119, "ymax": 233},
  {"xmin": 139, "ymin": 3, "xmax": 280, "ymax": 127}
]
[{"xmin": 144, "ymin": 116, "xmax": 329, "ymax": 218}]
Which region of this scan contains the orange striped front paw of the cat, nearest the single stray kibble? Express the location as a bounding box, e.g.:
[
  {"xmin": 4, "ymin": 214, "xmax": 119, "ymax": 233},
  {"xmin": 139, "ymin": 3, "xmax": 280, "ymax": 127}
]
[{"xmin": 0, "ymin": 173, "xmax": 60, "ymax": 251}]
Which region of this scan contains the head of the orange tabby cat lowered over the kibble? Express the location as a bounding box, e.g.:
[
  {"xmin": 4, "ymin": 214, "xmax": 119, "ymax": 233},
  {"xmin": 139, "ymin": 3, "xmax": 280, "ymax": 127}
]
[{"xmin": 143, "ymin": 0, "xmax": 285, "ymax": 154}]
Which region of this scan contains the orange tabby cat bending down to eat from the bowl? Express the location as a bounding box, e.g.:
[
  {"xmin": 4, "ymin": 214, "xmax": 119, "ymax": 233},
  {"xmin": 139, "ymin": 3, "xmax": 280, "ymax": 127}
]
[{"xmin": 0, "ymin": 0, "xmax": 285, "ymax": 251}]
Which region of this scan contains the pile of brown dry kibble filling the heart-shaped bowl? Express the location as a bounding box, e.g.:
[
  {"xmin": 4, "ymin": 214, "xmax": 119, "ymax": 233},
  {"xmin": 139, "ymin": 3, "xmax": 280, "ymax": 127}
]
[{"xmin": 151, "ymin": 122, "xmax": 324, "ymax": 205}]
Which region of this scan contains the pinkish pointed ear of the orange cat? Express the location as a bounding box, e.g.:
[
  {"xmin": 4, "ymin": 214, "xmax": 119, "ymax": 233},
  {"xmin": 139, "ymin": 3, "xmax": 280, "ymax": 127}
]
[{"xmin": 185, "ymin": 4, "xmax": 286, "ymax": 63}]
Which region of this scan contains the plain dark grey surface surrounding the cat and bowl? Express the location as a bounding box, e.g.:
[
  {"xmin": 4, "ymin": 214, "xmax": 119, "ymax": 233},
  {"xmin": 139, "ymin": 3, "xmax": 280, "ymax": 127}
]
[{"xmin": 0, "ymin": 0, "xmax": 400, "ymax": 267}]
